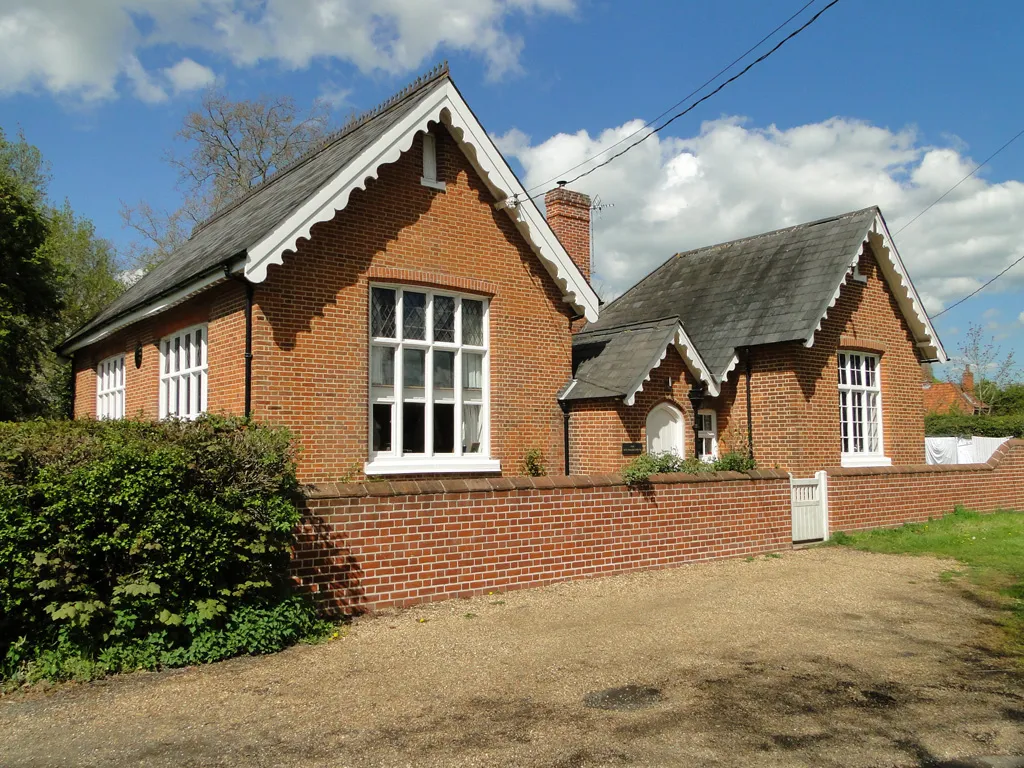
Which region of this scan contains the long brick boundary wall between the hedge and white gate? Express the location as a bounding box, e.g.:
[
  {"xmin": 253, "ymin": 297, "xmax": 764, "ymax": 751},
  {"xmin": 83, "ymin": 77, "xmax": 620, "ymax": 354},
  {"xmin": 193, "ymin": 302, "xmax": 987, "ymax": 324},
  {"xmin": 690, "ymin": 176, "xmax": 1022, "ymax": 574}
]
[{"xmin": 293, "ymin": 471, "xmax": 792, "ymax": 613}]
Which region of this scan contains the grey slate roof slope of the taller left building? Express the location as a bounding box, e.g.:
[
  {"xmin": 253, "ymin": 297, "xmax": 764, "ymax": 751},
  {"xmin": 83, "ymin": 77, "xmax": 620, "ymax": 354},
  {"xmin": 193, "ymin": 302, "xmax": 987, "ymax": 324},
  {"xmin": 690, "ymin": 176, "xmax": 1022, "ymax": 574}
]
[{"xmin": 62, "ymin": 65, "xmax": 450, "ymax": 347}]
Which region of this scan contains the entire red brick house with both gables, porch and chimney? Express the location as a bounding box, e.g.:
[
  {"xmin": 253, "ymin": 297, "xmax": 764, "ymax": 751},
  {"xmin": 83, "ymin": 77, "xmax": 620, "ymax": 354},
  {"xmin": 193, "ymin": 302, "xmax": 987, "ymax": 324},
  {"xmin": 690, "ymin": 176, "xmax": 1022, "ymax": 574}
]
[{"xmin": 62, "ymin": 68, "xmax": 945, "ymax": 482}]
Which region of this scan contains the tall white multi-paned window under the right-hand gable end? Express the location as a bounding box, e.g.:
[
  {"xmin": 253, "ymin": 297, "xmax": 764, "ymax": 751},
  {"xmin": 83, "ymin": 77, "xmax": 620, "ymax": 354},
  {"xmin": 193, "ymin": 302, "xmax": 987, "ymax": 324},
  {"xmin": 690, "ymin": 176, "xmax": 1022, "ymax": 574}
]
[{"xmin": 836, "ymin": 349, "xmax": 892, "ymax": 467}]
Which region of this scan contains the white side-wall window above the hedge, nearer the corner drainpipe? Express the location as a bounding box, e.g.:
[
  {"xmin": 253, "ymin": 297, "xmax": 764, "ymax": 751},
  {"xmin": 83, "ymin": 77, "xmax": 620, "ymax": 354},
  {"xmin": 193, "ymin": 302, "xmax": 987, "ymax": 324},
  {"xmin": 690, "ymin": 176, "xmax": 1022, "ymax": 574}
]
[{"xmin": 160, "ymin": 323, "xmax": 210, "ymax": 421}]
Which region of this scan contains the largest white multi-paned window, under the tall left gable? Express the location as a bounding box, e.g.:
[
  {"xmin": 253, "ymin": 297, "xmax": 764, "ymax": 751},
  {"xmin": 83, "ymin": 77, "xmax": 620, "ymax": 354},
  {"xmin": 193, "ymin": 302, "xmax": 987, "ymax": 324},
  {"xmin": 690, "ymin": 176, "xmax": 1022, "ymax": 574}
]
[{"xmin": 366, "ymin": 285, "xmax": 500, "ymax": 474}]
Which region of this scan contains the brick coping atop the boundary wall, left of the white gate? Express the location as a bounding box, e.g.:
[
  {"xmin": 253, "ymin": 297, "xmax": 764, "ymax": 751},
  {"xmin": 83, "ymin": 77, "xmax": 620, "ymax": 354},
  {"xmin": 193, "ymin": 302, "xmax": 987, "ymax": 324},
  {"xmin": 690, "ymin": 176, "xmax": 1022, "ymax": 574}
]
[{"xmin": 304, "ymin": 469, "xmax": 790, "ymax": 499}]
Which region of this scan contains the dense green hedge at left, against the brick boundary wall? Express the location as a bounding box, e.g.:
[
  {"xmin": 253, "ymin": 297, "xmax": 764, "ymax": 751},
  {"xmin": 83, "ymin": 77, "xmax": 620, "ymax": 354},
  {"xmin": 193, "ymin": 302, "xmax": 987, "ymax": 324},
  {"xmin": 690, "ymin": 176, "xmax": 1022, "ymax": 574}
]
[{"xmin": 0, "ymin": 417, "xmax": 326, "ymax": 682}]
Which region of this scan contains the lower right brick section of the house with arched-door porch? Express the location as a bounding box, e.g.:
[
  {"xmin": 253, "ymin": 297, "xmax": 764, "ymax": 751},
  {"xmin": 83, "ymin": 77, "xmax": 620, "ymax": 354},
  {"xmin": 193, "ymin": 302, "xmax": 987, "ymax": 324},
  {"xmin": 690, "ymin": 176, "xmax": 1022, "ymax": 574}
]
[{"xmin": 562, "ymin": 208, "xmax": 946, "ymax": 474}]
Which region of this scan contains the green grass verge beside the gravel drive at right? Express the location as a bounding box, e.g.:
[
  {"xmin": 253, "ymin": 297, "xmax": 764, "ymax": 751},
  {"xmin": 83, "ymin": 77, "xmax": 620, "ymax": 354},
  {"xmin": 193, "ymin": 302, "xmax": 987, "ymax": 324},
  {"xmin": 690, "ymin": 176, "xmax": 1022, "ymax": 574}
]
[{"xmin": 830, "ymin": 508, "xmax": 1024, "ymax": 663}]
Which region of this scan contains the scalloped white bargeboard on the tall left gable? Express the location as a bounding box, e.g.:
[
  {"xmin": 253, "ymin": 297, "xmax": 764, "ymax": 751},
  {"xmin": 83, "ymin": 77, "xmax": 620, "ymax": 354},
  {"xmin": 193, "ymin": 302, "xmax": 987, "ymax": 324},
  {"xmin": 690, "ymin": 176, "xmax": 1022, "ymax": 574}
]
[{"xmin": 245, "ymin": 81, "xmax": 600, "ymax": 322}]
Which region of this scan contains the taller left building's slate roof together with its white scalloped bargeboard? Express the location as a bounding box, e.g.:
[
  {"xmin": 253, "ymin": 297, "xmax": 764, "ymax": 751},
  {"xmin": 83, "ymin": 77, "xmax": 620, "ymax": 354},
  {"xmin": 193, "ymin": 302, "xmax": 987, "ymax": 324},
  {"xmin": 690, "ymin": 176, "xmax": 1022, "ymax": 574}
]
[{"xmin": 61, "ymin": 65, "xmax": 600, "ymax": 352}]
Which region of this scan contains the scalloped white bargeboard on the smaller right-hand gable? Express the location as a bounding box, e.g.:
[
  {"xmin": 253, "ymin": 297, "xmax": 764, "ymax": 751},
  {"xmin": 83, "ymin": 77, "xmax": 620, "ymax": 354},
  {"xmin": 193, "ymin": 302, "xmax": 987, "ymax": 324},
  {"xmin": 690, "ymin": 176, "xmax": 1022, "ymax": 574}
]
[{"xmin": 804, "ymin": 213, "xmax": 949, "ymax": 362}]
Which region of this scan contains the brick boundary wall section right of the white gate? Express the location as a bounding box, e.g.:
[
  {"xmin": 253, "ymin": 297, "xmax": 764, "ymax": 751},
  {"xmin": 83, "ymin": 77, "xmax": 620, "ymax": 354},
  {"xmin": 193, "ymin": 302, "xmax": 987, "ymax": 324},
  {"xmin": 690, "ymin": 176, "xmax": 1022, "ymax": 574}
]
[{"xmin": 827, "ymin": 440, "xmax": 1024, "ymax": 531}]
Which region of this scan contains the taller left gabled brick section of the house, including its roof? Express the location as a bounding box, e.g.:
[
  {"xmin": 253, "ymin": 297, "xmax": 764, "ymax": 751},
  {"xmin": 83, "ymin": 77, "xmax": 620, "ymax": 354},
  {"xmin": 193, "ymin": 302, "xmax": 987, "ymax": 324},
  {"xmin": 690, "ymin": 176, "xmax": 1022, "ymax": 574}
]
[{"xmin": 62, "ymin": 68, "xmax": 599, "ymax": 481}]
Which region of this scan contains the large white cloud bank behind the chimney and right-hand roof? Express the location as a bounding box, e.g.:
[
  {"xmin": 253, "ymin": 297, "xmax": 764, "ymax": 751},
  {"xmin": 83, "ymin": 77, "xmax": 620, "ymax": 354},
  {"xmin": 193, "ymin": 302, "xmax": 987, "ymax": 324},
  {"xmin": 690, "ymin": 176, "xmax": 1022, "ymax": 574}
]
[{"xmin": 497, "ymin": 118, "xmax": 1024, "ymax": 311}]
